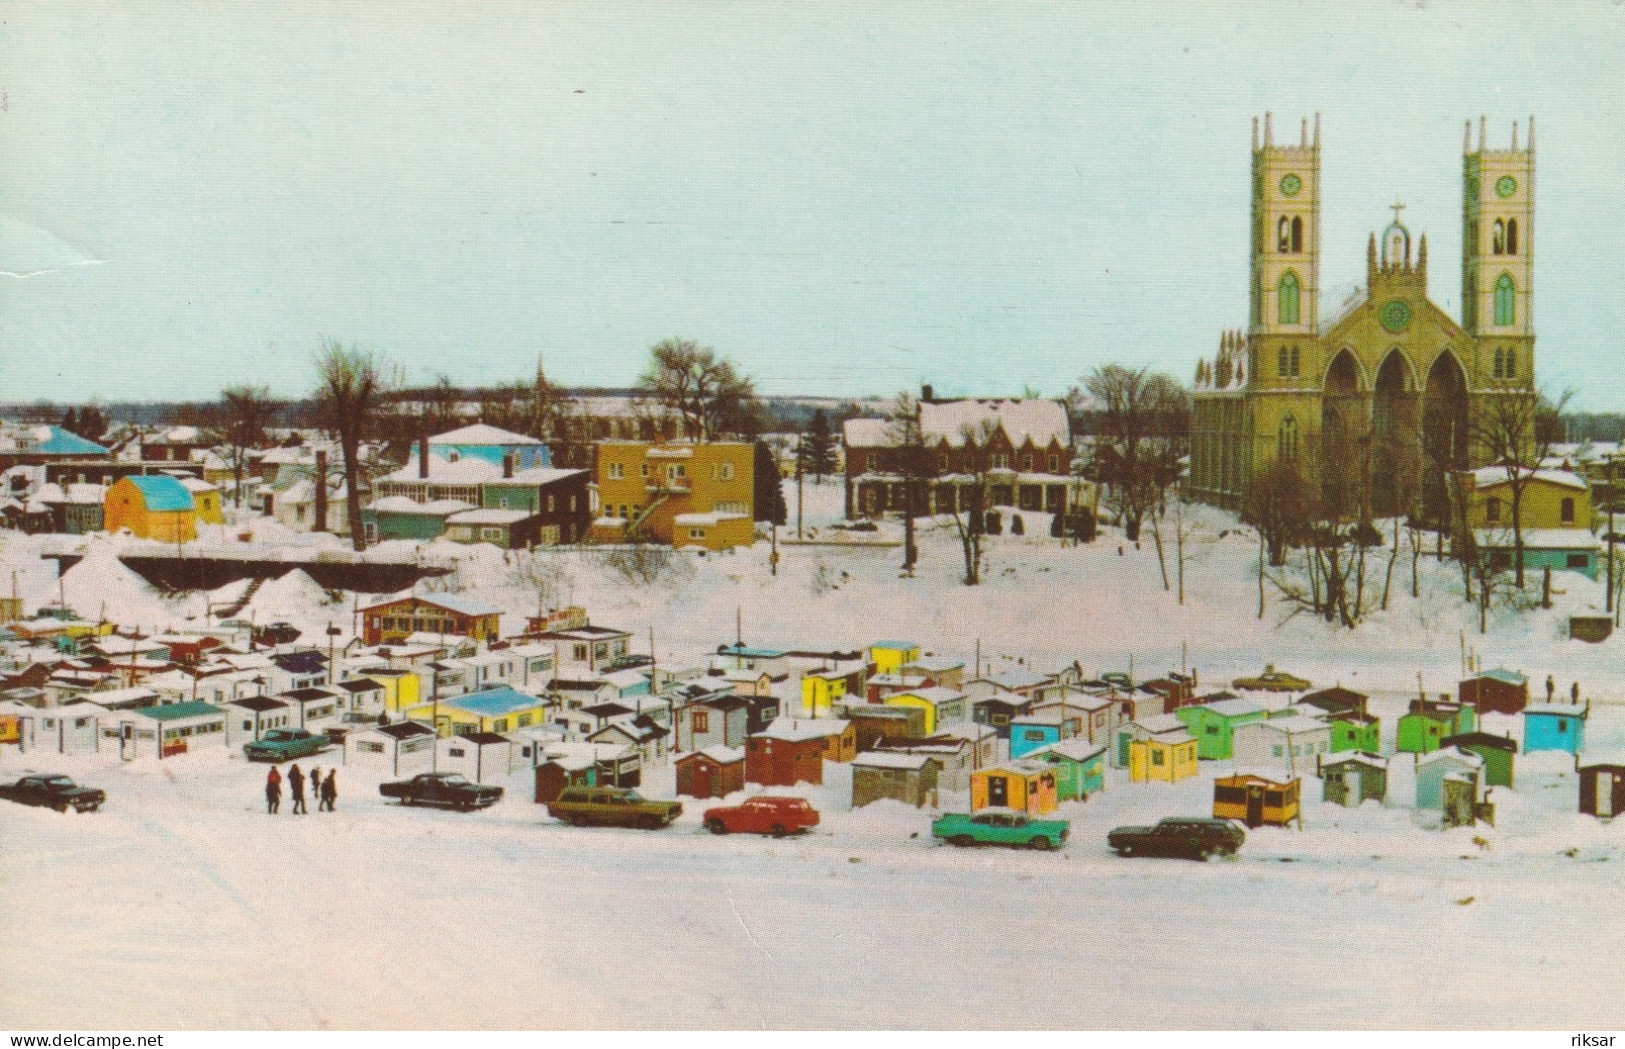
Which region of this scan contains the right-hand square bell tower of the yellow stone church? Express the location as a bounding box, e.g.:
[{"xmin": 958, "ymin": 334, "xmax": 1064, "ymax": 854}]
[{"xmin": 1461, "ymin": 117, "xmax": 1534, "ymax": 388}]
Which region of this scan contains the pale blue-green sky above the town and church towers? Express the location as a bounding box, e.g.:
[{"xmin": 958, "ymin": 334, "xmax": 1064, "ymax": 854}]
[{"xmin": 0, "ymin": 0, "xmax": 1625, "ymax": 409}]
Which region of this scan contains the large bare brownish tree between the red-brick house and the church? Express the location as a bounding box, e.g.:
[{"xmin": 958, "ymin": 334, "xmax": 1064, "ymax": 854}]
[{"xmin": 1071, "ymin": 364, "xmax": 1191, "ymax": 541}]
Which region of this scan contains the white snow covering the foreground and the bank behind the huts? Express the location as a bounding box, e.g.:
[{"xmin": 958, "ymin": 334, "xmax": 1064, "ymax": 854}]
[{"xmin": 0, "ymin": 484, "xmax": 1625, "ymax": 1030}]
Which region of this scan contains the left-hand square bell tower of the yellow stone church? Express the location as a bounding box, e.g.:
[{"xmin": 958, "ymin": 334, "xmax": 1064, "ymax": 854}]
[{"xmin": 1248, "ymin": 114, "xmax": 1323, "ymax": 390}]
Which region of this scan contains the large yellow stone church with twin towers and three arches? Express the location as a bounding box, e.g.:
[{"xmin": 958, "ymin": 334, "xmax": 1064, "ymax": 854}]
[{"xmin": 1190, "ymin": 114, "xmax": 1534, "ymax": 516}]
